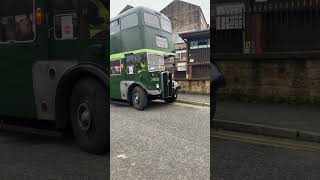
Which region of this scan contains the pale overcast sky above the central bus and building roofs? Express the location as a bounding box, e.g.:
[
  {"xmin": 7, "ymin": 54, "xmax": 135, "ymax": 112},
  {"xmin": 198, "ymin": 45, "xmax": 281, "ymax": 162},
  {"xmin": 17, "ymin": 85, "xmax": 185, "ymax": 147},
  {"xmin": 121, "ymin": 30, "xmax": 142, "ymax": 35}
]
[{"xmin": 110, "ymin": 0, "xmax": 210, "ymax": 24}]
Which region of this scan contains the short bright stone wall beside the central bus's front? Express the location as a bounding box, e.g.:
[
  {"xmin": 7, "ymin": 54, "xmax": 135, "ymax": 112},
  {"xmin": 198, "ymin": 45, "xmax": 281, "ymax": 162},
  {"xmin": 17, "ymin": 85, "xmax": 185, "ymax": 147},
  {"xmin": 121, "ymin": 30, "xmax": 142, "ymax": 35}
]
[{"xmin": 176, "ymin": 79, "xmax": 210, "ymax": 94}]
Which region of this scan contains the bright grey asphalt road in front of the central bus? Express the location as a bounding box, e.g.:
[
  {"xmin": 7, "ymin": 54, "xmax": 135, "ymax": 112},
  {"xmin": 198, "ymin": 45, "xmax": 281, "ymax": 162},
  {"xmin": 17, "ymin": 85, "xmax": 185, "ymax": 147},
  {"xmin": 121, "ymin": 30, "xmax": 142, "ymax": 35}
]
[{"xmin": 111, "ymin": 102, "xmax": 210, "ymax": 180}]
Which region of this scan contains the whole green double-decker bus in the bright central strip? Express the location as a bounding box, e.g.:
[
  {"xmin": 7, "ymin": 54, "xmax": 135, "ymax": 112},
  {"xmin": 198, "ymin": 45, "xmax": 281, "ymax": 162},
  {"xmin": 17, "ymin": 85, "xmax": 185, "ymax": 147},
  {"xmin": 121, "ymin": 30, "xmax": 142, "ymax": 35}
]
[{"xmin": 110, "ymin": 7, "xmax": 179, "ymax": 110}]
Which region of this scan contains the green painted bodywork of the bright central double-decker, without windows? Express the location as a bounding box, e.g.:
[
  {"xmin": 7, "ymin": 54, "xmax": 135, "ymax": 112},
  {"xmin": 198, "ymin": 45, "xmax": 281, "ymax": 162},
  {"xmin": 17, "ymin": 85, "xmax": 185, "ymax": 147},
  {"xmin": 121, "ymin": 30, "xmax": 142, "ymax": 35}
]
[{"xmin": 110, "ymin": 7, "xmax": 175, "ymax": 99}]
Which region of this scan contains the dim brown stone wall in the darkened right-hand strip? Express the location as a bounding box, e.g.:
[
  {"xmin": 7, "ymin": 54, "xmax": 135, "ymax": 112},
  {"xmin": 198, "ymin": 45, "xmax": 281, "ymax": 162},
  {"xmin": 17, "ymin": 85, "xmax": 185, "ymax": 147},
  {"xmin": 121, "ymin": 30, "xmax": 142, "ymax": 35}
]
[{"xmin": 216, "ymin": 58, "xmax": 320, "ymax": 103}]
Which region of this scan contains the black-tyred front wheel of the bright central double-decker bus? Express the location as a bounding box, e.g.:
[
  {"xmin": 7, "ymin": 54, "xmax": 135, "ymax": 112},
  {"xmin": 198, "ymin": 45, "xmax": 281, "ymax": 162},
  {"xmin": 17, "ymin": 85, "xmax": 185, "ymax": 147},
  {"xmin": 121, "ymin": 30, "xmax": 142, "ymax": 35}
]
[{"xmin": 131, "ymin": 86, "xmax": 148, "ymax": 111}]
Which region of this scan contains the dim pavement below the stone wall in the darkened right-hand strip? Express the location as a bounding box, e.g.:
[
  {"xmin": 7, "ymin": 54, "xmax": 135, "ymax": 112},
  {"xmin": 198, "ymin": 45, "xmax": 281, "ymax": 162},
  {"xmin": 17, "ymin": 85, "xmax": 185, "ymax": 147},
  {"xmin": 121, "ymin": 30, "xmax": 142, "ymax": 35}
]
[{"xmin": 215, "ymin": 101, "xmax": 320, "ymax": 133}]
